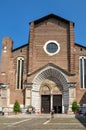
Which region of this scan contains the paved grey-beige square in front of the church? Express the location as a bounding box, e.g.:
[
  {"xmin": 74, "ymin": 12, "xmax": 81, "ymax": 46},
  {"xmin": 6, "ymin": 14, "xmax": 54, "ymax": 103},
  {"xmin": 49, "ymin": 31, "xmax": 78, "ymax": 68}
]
[{"xmin": 0, "ymin": 114, "xmax": 86, "ymax": 130}]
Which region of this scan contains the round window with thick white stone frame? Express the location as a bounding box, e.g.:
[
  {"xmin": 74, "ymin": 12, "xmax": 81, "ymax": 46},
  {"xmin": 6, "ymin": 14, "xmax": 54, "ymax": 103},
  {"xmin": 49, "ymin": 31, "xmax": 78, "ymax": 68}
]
[{"xmin": 44, "ymin": 40, "xmax": 60, "ymax": 56}]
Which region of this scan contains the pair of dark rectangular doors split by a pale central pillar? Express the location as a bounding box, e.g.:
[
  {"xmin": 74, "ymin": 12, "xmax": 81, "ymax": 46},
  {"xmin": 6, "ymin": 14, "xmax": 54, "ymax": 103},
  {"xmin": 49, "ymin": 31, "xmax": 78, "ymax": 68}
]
[{"xmin": 41, "ymin": 95, "xmax": 62, "ymax": 113}]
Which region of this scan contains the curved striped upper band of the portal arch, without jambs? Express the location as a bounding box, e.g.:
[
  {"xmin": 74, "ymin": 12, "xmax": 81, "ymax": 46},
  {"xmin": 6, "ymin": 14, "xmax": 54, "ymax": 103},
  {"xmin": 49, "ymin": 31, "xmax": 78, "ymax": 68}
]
[{"xmin": 33, "ymin": 66, "xmax": 68, "ymax": 91}]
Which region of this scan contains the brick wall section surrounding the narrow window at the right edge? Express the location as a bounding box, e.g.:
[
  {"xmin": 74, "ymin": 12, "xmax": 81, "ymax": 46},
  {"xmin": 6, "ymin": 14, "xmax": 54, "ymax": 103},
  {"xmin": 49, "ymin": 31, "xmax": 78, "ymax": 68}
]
[{"xmin": 75, "ymin": 45, "xmax": 86, "ymax": 103}]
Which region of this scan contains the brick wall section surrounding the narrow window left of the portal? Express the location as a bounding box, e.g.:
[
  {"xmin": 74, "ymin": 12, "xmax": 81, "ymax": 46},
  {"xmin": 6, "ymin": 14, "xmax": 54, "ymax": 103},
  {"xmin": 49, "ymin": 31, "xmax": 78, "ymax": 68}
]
[{"xmin": 10, "ymin": 46, "xmax": 28, "ymax": 104}]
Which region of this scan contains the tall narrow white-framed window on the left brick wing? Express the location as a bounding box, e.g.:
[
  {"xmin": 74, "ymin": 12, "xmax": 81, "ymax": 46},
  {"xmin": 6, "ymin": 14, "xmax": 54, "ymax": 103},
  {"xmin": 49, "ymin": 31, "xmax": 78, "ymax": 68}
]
[{"xmin": 17, "ymin": 57, "xmax": 24, "ymax": 89}]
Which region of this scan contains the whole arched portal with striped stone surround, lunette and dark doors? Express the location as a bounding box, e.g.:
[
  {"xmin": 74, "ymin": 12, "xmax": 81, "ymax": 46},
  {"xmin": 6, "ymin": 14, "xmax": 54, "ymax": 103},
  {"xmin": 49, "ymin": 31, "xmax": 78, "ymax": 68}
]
[{"xmin": 32, "ymin": 66, "xmax": 69, "ymax": 113}]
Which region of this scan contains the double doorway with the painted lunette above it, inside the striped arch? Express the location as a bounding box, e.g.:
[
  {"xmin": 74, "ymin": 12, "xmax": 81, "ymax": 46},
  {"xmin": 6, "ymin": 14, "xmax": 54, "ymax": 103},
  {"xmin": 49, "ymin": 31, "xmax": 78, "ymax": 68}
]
[{"xmin": 40, "ymin": 79, "xmax": 62, "ymax": 113}]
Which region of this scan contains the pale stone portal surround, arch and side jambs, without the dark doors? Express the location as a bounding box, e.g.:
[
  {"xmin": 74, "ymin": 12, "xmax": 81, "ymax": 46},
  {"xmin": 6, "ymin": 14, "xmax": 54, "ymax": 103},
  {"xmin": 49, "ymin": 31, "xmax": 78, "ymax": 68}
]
[{"xmin": 32, "ymin": 66, "xmax": 69, "ymax": 111}]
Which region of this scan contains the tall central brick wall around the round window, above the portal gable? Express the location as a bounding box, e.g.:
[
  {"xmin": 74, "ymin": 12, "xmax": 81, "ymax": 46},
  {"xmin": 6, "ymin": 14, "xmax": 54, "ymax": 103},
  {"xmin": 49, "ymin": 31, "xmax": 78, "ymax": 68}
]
[{"xmin": 29, "ymin": 18, "xmax": 70, "ymax": 72}]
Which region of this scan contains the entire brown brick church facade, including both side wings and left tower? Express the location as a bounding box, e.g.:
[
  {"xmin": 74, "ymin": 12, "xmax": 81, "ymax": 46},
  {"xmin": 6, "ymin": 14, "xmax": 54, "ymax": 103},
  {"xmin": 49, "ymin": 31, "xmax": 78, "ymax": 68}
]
[{"xmin": 0, "ymin": 15, "xmax": 86, "ymax": 104}]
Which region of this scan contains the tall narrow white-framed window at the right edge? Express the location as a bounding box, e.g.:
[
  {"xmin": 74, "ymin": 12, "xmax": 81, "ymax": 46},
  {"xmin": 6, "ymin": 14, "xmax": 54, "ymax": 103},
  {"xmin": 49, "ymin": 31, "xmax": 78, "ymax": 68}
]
[{"xmin": 80, "ymin": 57, "xmax": 86, "ymax": 88}]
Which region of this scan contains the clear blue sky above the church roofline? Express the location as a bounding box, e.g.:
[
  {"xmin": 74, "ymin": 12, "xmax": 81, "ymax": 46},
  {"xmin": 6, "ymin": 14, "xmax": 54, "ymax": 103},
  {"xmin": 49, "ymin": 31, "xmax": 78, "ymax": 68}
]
[{"xmin": 0, "ymin": 0, "xmax": 86, "ymax": 51}]
